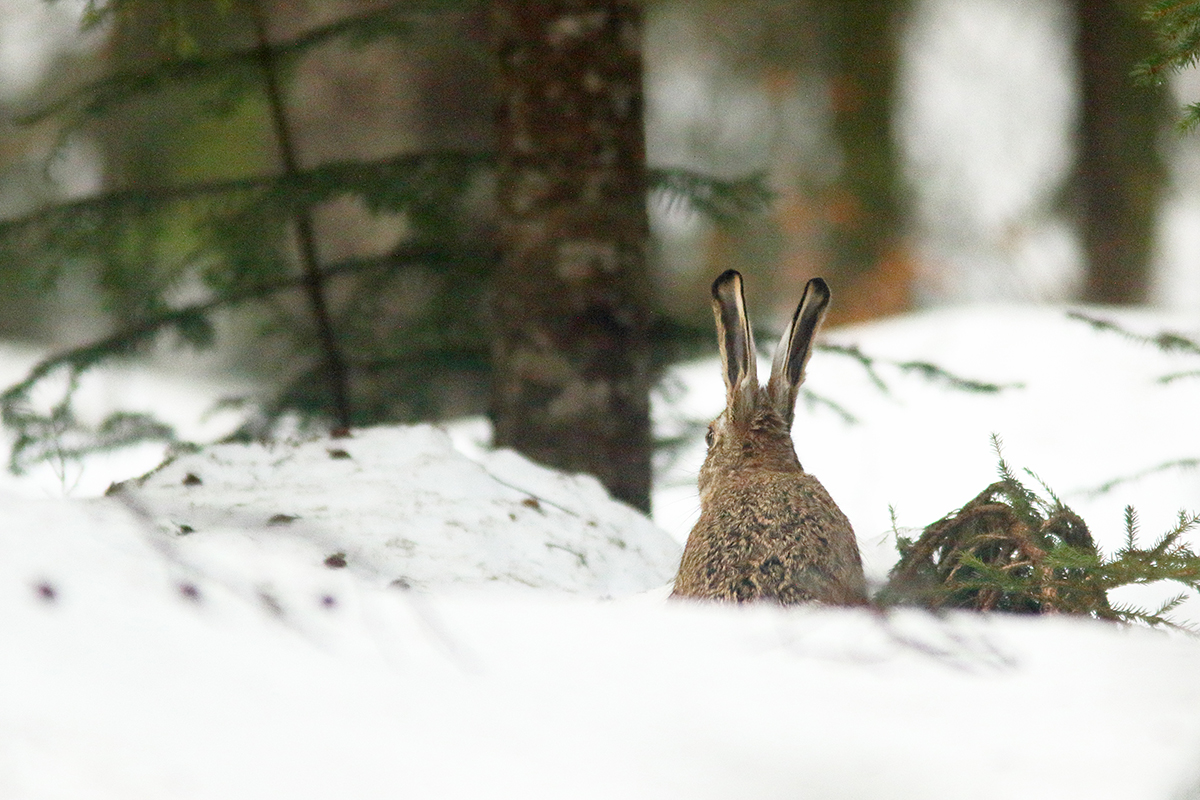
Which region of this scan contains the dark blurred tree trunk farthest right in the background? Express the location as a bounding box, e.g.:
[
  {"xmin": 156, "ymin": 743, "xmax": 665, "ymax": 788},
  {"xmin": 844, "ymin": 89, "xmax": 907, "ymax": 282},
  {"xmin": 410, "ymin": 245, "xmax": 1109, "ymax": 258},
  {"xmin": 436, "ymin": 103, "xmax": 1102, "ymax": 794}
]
[{"xmin": 1074, "ymin": 0, "xmax": 1166, "ymax": 303}]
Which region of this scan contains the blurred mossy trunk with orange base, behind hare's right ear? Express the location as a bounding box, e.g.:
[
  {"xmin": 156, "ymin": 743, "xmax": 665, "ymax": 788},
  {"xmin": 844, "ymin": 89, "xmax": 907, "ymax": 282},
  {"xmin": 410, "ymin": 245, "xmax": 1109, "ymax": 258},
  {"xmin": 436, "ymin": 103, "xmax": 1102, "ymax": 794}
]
[{"xmin": 814, "ymin": 0, "xmax": 911, "ymax": 315}]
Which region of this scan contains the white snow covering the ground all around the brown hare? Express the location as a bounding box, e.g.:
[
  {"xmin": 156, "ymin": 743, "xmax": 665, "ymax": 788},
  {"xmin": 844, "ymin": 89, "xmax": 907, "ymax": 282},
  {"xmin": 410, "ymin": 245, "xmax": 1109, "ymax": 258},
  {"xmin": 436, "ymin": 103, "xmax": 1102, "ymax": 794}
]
[{"xmin": 0, "ymin": 307, "xmax": 1200, "ymax": 800}]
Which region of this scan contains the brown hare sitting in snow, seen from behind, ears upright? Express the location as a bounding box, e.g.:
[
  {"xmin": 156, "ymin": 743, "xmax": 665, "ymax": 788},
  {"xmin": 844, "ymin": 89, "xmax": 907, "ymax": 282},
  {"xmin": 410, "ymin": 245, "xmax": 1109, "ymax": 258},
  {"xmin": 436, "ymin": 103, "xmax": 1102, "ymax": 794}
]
[{"xmin": 672, "ymin": 270, "xmax": 866, "ymax": 604}]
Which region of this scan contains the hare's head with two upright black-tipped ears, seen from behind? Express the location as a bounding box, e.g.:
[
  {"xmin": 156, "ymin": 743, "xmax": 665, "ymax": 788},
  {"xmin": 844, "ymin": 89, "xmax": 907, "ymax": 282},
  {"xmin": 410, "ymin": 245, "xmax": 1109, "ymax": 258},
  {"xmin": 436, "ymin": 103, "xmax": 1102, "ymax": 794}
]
[{"xmin": 700, "ymin": 270, "xmax": 829, "ymax": 501}]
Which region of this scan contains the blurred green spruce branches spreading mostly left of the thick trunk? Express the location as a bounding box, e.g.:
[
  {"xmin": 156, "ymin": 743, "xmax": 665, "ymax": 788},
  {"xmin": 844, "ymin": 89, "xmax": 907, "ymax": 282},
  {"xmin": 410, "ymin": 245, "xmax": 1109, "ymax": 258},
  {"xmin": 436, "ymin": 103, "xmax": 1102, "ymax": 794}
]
[{"xmin": 0, "ymin": 0, "xmax": 770, "ymax": 469}]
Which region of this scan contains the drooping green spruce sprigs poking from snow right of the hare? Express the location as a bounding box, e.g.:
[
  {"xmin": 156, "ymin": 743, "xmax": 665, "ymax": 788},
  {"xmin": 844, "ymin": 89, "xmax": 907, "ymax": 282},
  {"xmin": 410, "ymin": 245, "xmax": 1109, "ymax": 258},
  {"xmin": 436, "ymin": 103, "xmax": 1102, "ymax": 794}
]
[{"xmin": 876, "ymin": 437, "xmax": 1200, "ymax": 627}]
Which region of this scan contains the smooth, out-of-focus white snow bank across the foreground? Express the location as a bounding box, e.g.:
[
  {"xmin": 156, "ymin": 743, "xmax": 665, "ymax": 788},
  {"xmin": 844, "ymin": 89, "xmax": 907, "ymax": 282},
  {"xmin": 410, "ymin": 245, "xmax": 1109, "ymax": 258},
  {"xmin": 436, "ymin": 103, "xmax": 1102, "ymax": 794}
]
[{"xmin": 7, "ymin": 491, "xmax": 1200, "ymax": 800}]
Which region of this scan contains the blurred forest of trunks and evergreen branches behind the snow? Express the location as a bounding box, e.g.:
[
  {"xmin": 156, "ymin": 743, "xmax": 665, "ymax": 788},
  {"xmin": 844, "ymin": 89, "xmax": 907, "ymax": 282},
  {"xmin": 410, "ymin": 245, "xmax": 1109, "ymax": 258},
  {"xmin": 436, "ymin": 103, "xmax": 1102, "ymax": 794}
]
[{"xmin": 0, "ymin": 0, "xmax": 1200, "ymax": 507}]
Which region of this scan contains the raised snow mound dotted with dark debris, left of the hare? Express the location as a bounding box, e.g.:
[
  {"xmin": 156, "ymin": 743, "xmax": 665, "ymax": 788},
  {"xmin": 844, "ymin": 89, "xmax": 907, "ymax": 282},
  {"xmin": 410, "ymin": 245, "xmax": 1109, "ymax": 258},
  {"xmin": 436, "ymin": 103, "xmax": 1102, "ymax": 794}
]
[{"xmin": 118, "ymin": 426, "xmax": 679, "ymax": 597}]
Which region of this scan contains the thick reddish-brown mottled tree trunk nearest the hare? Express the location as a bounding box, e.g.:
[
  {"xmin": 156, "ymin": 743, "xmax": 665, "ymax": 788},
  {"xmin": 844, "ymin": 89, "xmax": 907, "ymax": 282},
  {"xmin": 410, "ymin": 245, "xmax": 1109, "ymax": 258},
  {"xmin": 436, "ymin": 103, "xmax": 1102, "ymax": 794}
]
[{"xmin": 491, "ymin": 0, "xmax": 650, "ymax": 510}]
